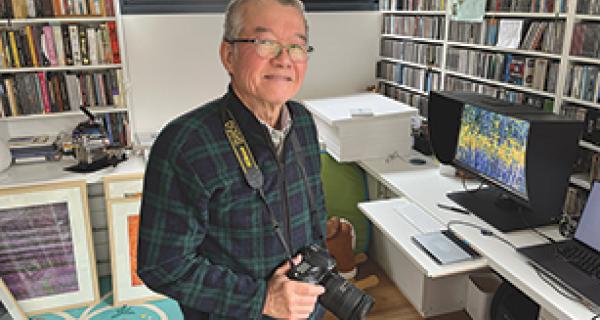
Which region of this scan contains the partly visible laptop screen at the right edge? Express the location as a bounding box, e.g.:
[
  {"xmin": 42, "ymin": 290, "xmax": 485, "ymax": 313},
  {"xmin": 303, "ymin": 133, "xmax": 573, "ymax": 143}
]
[{"xmin": 575, "ymin": 182, "xmax": 600, "ymax": 251}]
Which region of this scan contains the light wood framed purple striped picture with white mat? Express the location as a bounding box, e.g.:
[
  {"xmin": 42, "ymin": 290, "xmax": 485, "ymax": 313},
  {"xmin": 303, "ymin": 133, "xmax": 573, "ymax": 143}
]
[{"xmin": 0, "ymin": 181, "xmax": 99, "ymax": 315}]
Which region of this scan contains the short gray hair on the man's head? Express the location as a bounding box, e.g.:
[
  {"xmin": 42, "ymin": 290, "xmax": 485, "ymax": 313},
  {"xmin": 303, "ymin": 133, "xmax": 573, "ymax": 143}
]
[{"xmin": 223, "ymin": 0, "xmax": 308, "ymax": 40}]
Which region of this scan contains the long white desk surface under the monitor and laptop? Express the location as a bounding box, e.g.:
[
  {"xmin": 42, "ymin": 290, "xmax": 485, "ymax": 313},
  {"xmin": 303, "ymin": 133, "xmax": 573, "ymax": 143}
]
[{"xmin": 359, "ymin": 158, "xmax": 594, "ymax": 319}]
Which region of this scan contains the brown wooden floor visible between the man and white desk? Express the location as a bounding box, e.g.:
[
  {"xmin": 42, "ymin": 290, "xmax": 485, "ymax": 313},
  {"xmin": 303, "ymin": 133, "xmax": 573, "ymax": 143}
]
[{"xmin": 323, "ymin": 260, "xmax": 471, "ymax": 320}]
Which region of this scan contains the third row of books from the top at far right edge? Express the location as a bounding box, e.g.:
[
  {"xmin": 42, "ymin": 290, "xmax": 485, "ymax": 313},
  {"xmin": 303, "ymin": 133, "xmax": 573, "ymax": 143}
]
[{"xmin": 564, "ymin": 65, "xmax": 600, "ymax": 103}]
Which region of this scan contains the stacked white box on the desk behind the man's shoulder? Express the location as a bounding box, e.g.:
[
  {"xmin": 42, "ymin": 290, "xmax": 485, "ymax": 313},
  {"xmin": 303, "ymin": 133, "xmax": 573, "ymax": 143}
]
[{"xmin": 304, "ymin": 93, "xmax": 417, "ymax": 162}]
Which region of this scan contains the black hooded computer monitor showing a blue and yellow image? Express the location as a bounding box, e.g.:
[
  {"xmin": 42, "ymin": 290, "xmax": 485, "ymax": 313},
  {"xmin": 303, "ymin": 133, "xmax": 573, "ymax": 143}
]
[{"xmin": 428, "ymin": 92, "xmax": 582, "ymax": 232}]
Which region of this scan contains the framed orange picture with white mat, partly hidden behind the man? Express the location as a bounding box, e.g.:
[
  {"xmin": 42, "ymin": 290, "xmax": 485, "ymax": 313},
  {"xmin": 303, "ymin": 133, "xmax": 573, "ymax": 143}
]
[{"xmin": 107, "ymin": 196, "xmax": 166, "ymax": 306}]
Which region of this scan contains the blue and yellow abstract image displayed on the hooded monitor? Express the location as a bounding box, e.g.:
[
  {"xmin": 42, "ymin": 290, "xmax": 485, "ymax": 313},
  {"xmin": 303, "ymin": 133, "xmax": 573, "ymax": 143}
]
[{"xmin": 455, "ymin": 104, "xmax": 529, "ymax": 197}]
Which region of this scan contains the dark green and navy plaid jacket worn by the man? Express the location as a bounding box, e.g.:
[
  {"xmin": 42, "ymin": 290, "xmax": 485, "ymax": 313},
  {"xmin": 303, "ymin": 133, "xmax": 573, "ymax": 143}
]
[{"xmin": 138, "ymin": 88, "xmax": 326, "ymax": 319}]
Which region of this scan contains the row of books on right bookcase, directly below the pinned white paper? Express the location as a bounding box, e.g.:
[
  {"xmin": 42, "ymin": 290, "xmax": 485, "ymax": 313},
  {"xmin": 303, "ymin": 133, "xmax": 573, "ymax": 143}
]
[{"xmin": 446, "ymin": 48, "xmax": 559, "ymax": 93}]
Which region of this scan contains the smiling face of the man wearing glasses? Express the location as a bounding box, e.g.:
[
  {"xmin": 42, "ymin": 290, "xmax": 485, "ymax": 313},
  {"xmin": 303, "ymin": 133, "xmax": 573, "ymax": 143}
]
[{"xmin": 221, "ymin": 0, "xmax": 307, "ymax": 105}]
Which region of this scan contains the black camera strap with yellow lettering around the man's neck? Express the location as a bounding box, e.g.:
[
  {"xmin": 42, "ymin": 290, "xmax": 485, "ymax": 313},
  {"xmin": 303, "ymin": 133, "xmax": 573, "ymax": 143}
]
[{"xmin": 221, "ymin": 106, "xmax": 323, "ymax": 261}]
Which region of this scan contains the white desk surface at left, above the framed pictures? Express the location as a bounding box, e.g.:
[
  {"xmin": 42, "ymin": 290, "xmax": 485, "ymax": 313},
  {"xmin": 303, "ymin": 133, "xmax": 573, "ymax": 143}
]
[{"xmin": 0, "ymin": 157, "xmax": 146, "ymax": 188}]
